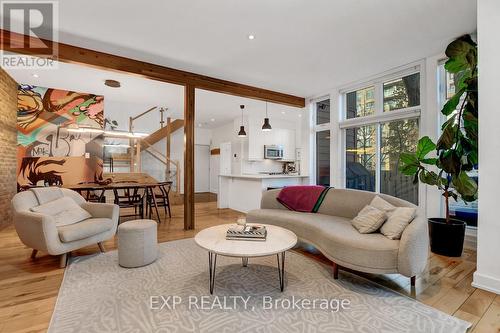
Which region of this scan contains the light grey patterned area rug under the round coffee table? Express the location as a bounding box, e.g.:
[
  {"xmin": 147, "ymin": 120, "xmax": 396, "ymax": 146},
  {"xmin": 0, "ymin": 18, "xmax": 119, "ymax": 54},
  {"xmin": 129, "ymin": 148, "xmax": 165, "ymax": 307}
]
[{"xmin": 48, "ymin": 239, "xmax": 470, "ymax": 333}]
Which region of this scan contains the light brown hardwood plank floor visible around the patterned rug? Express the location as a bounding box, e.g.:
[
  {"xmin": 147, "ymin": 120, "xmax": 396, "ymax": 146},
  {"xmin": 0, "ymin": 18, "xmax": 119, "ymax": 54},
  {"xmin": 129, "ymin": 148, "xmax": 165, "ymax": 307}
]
[{"xmin": 0, "ymin": 202, "xmax": 500, "ymax": 333}]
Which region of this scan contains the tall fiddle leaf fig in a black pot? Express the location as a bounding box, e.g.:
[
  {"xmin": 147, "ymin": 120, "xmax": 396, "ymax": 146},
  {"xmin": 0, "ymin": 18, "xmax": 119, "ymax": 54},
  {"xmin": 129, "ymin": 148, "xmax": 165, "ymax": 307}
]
[{"xmin": 400, "ymin": 35, "xmax": 478, "ymax": 257}]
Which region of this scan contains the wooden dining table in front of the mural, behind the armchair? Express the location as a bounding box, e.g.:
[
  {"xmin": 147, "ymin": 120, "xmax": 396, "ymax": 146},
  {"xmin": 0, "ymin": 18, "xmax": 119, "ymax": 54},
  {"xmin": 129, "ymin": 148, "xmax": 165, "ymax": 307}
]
[{"xmin": 63, "ymin": 181, "xmax": 166, "ymax": 221}]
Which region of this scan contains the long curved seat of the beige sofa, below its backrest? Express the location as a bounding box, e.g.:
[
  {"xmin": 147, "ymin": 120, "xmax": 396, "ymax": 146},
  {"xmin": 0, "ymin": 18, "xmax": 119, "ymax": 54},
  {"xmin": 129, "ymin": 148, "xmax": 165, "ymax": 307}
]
[{"xmin": 247, "ymin": 209, "xmax": 399, "ymax": 271}]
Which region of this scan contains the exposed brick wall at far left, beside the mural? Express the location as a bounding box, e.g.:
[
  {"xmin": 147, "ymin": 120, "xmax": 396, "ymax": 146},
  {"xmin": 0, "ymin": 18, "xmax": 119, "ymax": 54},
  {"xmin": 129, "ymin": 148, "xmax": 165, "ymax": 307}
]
[{"xmin": 0, "ymin": 68, "xmax": 17, "ymax": 229}]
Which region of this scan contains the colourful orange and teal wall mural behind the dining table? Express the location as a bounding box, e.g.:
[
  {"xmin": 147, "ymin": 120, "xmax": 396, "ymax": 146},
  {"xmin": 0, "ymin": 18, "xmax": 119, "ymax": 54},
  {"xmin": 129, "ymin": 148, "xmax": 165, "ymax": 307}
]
[{"xmin": 17, "ymin": 85, "xmax": 104, "ymax": 187}]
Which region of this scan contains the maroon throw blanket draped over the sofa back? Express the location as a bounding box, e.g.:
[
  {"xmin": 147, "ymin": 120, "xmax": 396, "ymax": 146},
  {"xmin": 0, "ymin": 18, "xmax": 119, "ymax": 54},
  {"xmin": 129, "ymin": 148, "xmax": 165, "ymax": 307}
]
[{"xmin": 276, "ymin": 185, "xmax": 330, "ymax": 213}]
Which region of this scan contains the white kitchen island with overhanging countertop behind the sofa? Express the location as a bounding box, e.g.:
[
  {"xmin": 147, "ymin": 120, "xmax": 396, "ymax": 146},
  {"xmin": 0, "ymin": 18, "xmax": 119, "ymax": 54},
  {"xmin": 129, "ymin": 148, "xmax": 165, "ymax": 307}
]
[{"xmin": 217, "ymin": 174, "xmax": 309, "ymax": 213}]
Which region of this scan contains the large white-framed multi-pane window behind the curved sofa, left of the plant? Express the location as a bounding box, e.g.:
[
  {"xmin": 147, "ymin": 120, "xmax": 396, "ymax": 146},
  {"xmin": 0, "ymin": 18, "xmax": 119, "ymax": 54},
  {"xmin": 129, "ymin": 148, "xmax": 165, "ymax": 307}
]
[{"xmin": 340, "ymin": 69, "xmax": 420, "ymax": 204}]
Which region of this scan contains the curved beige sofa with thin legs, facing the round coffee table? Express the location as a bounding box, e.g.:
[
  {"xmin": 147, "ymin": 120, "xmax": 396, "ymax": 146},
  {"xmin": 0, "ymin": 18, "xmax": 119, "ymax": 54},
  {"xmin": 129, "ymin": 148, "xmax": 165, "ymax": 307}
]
[{"xmin": 247, "ymin": 188, "xmax": 429, "ymax": 285}]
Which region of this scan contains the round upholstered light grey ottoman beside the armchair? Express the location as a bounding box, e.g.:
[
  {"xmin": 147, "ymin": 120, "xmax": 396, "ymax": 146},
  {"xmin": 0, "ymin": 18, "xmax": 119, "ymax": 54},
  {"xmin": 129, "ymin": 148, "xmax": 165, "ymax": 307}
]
[{"xmin": 118, "ymin": 220, "xmax": 158, "ymax": 268}]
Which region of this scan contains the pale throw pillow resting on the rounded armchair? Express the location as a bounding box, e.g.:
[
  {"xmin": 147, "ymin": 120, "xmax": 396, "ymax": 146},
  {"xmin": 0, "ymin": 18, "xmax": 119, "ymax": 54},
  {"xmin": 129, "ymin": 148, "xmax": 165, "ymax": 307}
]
[{"xmin": 30, "ymin": 197, "xmax": 92, "ymax": 227}]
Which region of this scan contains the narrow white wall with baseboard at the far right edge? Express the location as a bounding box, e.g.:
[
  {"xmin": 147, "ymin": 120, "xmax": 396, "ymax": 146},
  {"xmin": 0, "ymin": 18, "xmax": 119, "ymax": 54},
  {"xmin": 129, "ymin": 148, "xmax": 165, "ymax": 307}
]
[{"xmin": 473, "ymin": 0, "xmax": 500, "ymax": 294}]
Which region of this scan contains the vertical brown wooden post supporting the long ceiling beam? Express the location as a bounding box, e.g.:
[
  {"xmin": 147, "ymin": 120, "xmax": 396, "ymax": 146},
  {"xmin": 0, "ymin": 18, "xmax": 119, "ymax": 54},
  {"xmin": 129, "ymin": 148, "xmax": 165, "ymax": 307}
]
[{"xmin": 184, "ymin": 85, "xmax": 195, "ymax": 230}]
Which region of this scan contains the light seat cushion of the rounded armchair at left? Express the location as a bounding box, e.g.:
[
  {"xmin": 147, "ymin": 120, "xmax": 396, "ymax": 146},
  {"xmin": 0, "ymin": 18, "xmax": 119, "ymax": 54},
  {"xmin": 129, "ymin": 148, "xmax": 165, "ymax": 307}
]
[{"xmin": 57, "ymin": 218, "xmax": 113, "ymax": 243}]
